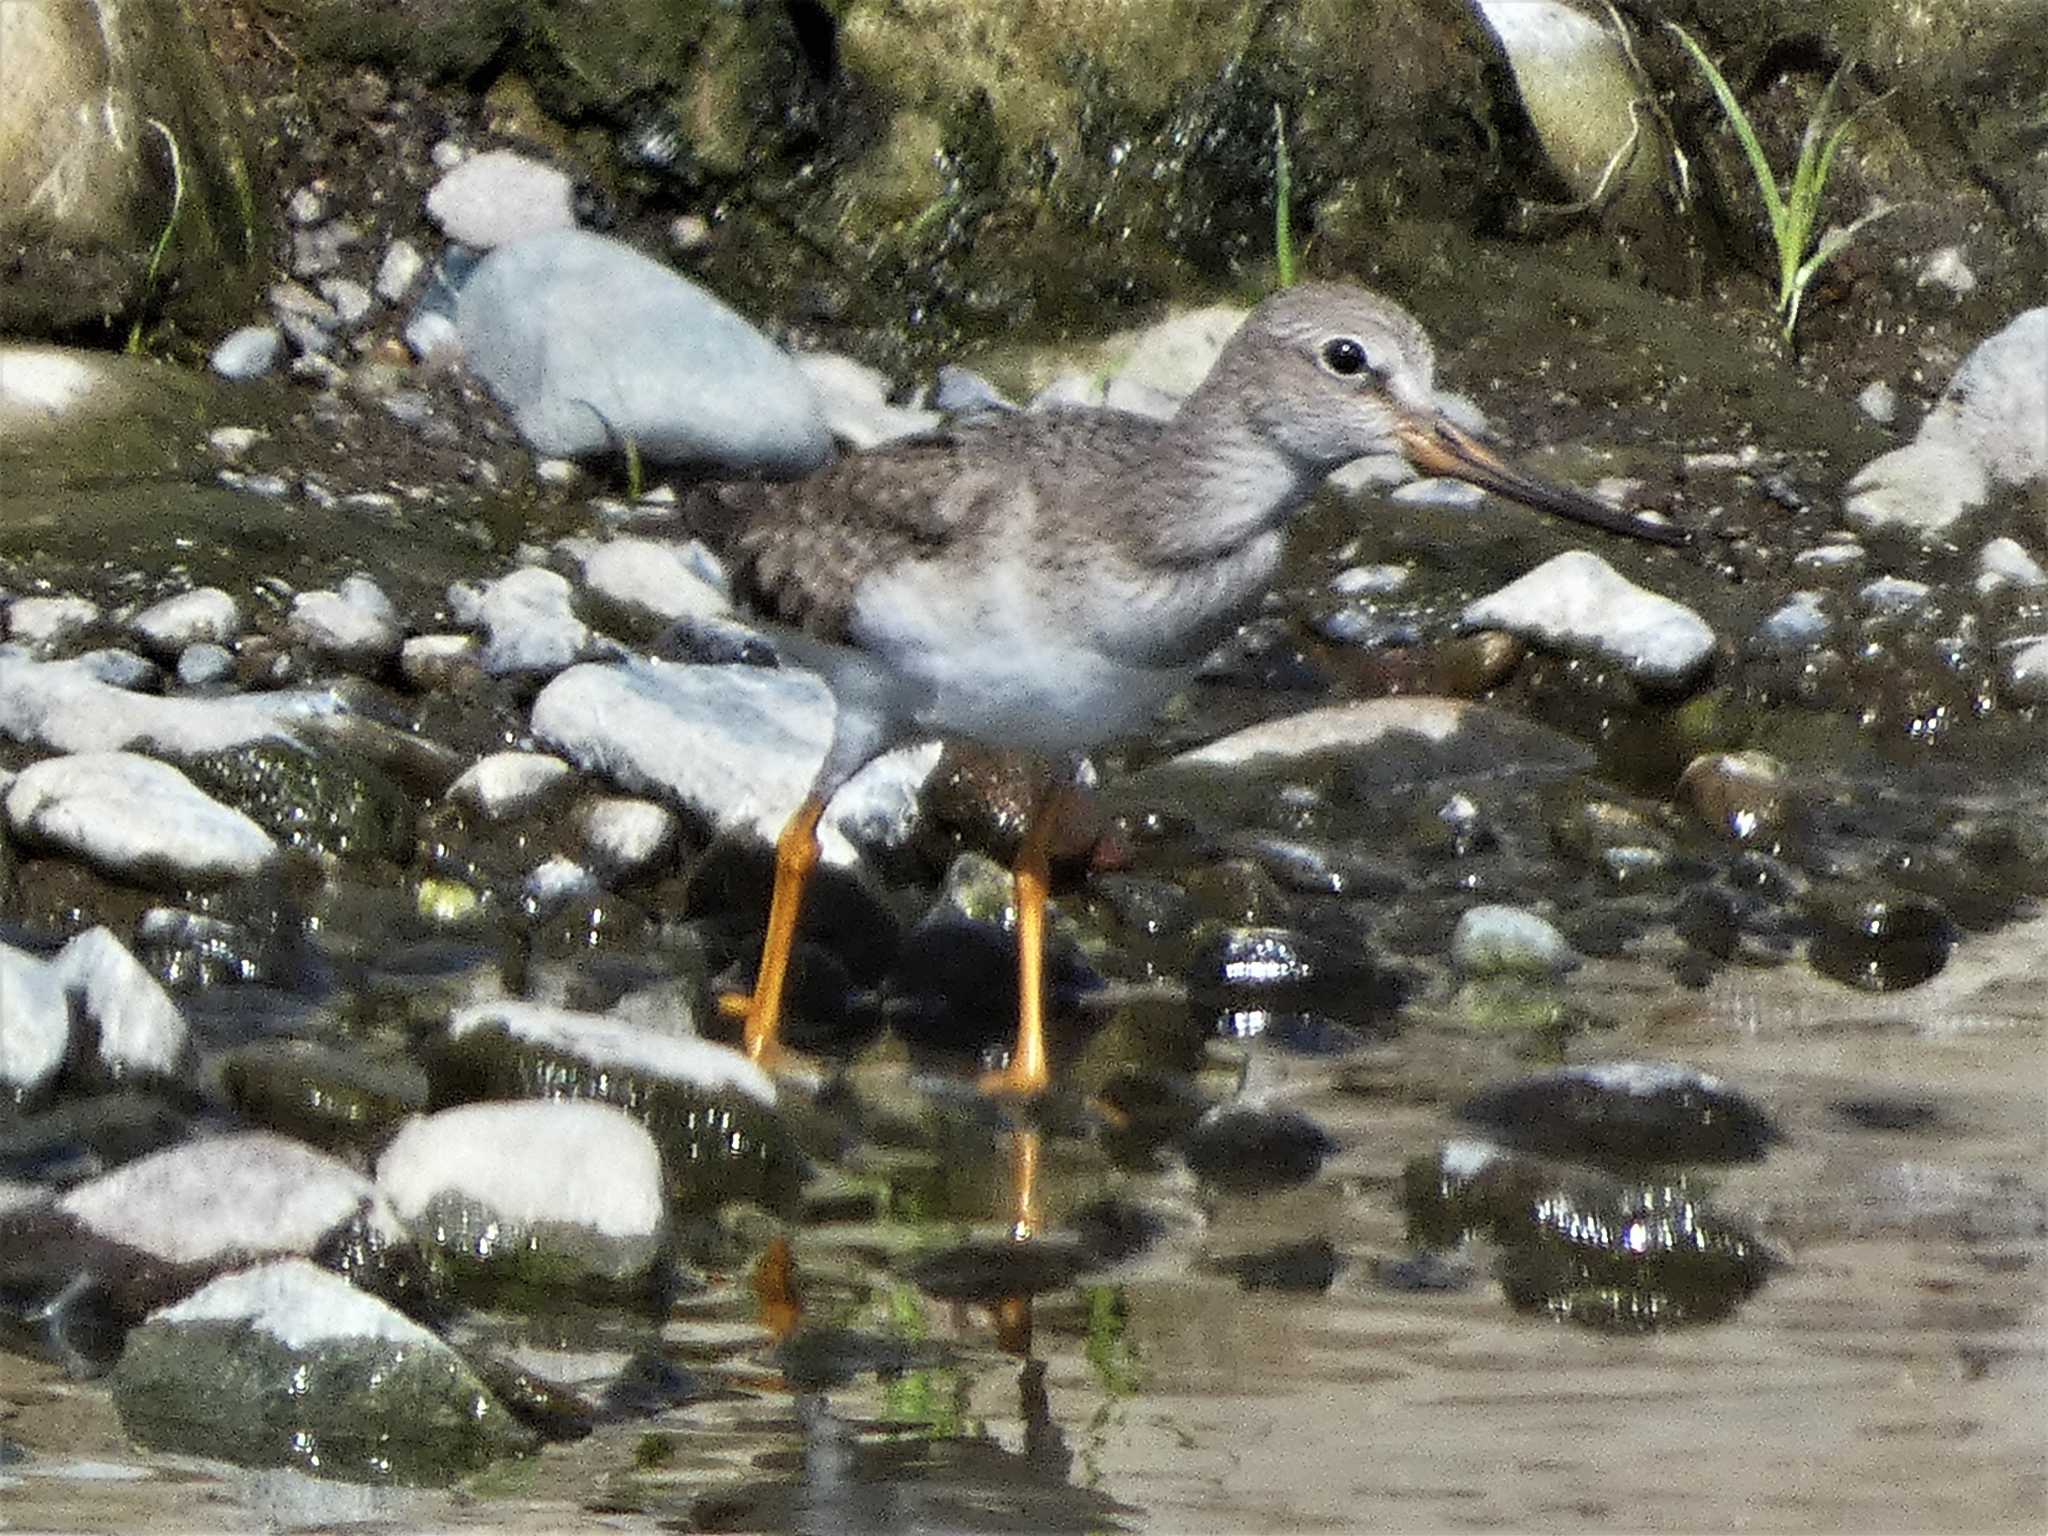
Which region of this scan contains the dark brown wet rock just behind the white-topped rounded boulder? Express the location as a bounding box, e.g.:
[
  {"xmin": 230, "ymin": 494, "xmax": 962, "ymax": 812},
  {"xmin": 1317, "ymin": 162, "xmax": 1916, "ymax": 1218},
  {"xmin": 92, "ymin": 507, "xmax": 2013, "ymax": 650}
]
[{"xmin": 219, "ymin": 1040, "xmax": 426, "ymax": 1153}]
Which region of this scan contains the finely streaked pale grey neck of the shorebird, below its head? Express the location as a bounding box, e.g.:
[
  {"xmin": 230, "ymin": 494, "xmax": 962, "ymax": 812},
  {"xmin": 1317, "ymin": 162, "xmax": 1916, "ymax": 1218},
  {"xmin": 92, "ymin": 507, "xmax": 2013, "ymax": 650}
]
[{"xmin": 1130, "ymin": 389, "xmax": 1323, "ymax": 565}]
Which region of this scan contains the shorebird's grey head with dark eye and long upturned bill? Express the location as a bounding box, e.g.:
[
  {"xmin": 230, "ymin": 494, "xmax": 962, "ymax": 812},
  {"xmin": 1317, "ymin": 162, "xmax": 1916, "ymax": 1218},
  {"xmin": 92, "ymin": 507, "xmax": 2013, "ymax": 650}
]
[{"xmin": 1202, "ymin": 283, "xmax": 1690, "ymax": 545}]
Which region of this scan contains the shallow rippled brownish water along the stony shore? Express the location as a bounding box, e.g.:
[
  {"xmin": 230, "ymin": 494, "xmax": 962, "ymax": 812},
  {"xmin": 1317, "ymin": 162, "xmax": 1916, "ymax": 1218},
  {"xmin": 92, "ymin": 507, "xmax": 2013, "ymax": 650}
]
[{"xmin": 0, "ymin": 901, "xmax": 2048, "ymax": 1532}]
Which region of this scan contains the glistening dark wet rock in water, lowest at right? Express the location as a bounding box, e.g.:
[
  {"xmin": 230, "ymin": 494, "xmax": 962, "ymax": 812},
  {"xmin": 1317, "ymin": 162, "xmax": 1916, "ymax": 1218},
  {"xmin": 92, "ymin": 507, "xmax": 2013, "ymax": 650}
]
[{"xmin": 1401, "ymin": 1143, "xmax": 1782, "ymax": 1333}]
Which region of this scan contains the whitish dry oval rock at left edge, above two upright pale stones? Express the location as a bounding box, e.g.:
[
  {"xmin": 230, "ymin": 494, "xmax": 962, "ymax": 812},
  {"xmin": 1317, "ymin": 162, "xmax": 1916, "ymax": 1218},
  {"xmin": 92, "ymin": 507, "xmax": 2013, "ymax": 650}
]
[{"xmin": 6, "ymin": 752, "xmax": 276, "ymax": 891}]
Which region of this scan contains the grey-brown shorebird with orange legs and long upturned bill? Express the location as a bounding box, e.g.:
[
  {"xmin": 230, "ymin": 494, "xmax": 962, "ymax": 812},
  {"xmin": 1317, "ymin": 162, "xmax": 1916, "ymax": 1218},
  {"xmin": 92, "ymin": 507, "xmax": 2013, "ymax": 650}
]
[{"xmin": 717, "ymin": 283, "xmax": 1688, "ymax": 1096}]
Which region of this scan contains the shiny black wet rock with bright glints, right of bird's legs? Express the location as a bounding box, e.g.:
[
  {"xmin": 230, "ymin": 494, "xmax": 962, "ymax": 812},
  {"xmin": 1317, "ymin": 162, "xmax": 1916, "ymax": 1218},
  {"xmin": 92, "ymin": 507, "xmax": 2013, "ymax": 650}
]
[{"xmin": 1184, "ymin": 924, "xmax": 1405, "ymax": 1047}]
